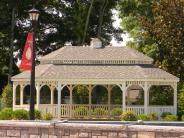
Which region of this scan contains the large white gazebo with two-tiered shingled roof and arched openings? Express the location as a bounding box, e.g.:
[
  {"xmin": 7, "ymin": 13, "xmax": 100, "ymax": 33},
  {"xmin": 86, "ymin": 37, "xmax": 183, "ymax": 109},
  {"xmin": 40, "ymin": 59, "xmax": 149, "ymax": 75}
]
[{"xmin": 12, "ymin": 42, "xmax": 179, "ymax": 118}]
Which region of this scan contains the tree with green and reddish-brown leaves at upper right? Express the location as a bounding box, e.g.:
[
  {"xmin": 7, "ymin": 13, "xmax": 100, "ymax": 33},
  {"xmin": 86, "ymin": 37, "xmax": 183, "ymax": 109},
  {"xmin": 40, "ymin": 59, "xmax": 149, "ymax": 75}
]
[{"xmin": 119, "ymin": 0, "xmax": 184, "ymax": 81}]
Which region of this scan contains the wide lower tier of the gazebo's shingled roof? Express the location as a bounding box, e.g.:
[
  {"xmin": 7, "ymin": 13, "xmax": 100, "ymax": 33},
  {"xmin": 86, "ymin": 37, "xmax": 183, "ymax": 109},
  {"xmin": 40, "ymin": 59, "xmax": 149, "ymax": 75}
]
[{"xmin": 13, "ymin": 64, "xmax": 178, "ymax": 81}]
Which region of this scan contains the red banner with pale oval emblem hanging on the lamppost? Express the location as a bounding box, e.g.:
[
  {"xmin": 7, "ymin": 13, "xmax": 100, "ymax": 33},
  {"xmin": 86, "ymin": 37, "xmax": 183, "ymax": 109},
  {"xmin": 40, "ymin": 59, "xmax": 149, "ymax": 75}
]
[{"xmin": 19, "ymin": 32, "xmax": 33, "ymax": 70}]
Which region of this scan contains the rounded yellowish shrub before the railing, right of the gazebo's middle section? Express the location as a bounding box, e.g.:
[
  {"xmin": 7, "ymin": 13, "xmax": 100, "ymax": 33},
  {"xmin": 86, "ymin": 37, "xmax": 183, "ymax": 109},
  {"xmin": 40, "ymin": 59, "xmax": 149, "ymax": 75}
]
[{"xmin": 121, "ymin": 111, "xmax": 137, "ymax": 121}]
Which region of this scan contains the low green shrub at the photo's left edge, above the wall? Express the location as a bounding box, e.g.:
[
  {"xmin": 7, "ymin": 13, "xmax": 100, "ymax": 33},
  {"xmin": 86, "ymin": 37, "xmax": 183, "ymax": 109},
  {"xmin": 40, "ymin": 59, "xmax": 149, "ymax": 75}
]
[{"xmin": 0, "ymin": 108, "xmax": 13, "ymax": 120}]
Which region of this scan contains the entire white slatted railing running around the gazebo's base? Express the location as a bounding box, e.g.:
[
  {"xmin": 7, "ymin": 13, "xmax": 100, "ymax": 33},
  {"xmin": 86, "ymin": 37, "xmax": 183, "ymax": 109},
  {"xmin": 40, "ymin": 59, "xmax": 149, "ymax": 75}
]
[{"xmin": 14, "ymin": 104, "xmax": 175, "ymax": 118}]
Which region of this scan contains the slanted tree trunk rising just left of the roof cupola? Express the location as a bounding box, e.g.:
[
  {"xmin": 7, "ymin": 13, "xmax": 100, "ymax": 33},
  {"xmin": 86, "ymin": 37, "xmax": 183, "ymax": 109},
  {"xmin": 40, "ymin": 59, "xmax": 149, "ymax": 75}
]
[{"xmin": 82, "ymin": 0, "xmax": 95, "ymax": 44}]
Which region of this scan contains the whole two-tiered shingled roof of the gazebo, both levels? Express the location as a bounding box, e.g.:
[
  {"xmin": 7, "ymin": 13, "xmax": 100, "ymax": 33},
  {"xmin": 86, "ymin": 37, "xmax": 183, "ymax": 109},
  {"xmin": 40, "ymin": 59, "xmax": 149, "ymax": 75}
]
[{"xmin": 12, "ymin": 46, "xmax": 179, "ymax": 81}]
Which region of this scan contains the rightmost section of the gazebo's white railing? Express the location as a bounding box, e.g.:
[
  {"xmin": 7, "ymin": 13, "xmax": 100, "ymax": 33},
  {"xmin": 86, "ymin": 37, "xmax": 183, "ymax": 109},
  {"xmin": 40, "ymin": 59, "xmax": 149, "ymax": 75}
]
[{"xmin": 148, "ymin": 106, "xmax": 175, "ymax": 116}]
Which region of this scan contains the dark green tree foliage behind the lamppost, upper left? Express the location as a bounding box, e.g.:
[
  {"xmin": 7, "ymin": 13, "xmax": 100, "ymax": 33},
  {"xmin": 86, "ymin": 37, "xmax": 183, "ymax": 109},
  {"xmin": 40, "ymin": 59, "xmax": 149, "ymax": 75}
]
[{"xmin": 0, "ymin": 0, "xmax": 118, "ymax": 75}]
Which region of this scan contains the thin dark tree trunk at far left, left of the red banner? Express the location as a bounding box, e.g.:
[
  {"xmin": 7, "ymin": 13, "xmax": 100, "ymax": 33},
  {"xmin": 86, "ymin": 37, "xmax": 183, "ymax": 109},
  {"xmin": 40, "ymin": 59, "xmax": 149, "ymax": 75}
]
[{"xmin": 8, "ymin": 6, "xmax": 15, "ymax": 83}]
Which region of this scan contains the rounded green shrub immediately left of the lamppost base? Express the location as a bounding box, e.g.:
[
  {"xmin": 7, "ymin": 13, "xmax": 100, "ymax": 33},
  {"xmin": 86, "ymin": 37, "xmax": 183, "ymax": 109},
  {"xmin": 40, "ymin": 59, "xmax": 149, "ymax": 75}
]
[{"xmin": 13, "ymin": 109, "xmax": 29, "ymax": 120}]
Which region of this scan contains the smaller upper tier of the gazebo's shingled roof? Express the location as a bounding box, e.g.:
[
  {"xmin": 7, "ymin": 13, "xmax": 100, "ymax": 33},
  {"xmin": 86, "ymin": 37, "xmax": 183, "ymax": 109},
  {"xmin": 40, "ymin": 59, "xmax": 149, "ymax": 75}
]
[{"xmin": 40, "ymin": 46, "xmax": 153, "ymax": 64}]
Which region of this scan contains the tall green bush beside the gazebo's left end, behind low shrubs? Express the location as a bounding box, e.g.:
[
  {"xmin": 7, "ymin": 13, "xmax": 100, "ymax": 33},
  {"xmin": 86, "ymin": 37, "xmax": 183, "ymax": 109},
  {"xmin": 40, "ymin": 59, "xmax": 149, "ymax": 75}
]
[{"xmin": 2, "ymin": 84, "xmax": 13, "ymax": 107}]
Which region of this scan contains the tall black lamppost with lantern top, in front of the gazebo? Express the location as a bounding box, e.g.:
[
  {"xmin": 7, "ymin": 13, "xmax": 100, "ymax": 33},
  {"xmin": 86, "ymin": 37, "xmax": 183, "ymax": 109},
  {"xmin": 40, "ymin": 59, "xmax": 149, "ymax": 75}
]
[{"xmin": 29, "ymin": 8, "xmax": 40, "ymax": 120}]
